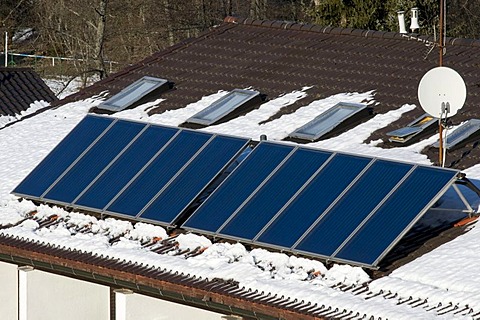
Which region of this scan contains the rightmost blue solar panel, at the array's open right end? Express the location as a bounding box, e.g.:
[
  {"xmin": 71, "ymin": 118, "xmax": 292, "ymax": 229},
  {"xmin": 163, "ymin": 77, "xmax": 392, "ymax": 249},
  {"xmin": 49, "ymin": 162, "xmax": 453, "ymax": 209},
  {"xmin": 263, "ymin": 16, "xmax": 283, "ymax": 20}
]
[{"xmin": 336, "ymin": 167, "xmax": 457, "ymax": 265}]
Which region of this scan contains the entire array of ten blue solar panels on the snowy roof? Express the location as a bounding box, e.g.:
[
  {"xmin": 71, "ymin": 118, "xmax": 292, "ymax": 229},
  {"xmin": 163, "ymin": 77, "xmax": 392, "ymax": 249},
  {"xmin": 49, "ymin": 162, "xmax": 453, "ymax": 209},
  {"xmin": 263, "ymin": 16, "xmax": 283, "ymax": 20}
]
[{"xmin": 13, "ymin": 115, "xmax": 458, "ymax": 267}]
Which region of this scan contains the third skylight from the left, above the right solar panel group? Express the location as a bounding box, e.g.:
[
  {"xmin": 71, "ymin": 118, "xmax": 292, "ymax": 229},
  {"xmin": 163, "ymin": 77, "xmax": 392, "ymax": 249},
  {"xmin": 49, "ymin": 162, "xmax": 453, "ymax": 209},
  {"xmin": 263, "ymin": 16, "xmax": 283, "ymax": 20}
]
[{"xmin": 289, "ymin": 102, "xmax": 367, "ymax": 141}]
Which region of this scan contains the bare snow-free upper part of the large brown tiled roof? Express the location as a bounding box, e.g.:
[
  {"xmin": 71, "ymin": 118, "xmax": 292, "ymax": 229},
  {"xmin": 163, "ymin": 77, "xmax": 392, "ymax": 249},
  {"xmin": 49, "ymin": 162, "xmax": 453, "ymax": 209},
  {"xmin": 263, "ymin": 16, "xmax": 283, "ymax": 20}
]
[{"xmin": 63, "ymin": 17, "xmax": 480, "ymax": 169}]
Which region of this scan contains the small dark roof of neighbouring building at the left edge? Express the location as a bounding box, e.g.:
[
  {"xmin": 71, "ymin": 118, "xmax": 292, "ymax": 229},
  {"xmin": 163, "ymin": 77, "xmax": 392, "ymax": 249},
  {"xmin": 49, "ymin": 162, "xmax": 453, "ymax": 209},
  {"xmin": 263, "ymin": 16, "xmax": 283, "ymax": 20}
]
[{"xmin": 0, "ymin": 68, "xmax": 57, "ymax": 116}]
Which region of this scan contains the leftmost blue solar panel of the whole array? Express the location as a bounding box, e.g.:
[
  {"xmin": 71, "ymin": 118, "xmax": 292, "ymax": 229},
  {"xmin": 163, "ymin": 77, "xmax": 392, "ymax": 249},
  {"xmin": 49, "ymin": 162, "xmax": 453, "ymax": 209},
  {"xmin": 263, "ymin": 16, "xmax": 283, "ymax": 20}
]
[{"xmin": 13, "ymin": 116, "xmax": 115, "ymax": 198}]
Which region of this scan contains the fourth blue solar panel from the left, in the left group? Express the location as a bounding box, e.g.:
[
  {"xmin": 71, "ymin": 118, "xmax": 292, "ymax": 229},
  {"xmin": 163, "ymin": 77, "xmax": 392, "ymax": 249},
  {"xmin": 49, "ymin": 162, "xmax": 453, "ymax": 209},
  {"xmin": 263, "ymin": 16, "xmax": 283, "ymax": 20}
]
[{"xmin": 106, "ymin": 131, "xmax": 212, "ymax": 217}]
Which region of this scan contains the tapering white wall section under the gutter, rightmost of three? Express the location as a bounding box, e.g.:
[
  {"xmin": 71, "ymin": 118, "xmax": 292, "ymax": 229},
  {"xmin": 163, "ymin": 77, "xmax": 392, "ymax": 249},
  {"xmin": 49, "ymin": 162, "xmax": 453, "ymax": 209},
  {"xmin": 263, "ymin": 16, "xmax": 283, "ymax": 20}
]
[{"xmin": 115, "ymin": 292, "xmax": 227, "ymax": 320}]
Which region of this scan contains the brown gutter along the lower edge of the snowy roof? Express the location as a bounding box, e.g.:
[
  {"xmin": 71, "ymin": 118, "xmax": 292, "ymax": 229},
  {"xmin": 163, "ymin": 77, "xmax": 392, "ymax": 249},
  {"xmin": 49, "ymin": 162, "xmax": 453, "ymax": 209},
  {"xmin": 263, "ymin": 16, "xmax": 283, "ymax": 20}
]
[{"xmin": 0, "ymin": 235, "xmax": 325, "ymax": 320}]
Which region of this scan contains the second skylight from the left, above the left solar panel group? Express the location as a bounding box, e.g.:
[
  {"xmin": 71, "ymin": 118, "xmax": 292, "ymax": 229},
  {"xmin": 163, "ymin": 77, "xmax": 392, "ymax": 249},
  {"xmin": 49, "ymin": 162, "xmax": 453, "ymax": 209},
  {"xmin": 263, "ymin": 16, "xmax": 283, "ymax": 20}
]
[{"xmin": 187, "ymin": 89, "xmax": 260, "ymax": 126}]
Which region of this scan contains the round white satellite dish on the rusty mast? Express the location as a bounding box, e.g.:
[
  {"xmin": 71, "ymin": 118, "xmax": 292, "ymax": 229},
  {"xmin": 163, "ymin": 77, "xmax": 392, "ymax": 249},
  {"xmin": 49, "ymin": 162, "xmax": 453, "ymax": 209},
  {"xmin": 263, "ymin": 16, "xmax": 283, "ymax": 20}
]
[{"xmin": 418, "ymin": 67, "xmax": 467, "ymax": 118}]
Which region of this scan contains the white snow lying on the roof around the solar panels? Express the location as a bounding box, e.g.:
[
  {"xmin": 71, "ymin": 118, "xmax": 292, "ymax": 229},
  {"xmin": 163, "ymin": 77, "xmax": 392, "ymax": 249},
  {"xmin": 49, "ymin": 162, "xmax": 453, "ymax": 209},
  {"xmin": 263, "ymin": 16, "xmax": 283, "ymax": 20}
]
[{"xmin": 0, "ymin": 88, "xmax": 480, "ymax": 319}]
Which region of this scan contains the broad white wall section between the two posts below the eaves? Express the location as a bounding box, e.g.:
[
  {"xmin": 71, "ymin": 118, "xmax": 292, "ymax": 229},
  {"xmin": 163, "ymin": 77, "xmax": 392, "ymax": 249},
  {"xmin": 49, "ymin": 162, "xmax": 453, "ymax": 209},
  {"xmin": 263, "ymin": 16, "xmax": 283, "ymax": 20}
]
[{"xmin": 26, "ymin": 270, "xmax": 110, "ymax": 320}]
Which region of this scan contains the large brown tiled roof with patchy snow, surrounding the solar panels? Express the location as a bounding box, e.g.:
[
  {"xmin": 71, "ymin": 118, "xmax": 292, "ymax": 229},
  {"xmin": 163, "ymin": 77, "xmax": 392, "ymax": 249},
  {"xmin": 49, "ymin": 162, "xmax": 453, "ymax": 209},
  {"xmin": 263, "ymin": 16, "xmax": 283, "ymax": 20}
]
[{"xmin": 4, "ymin": 19, "xmax": 480, "ymax": 319}]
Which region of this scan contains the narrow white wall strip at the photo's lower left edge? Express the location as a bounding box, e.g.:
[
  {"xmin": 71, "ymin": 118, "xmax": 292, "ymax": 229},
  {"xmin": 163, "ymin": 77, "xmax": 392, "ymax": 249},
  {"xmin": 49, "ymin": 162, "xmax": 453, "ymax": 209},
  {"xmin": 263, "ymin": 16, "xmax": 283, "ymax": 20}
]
[{"xmin": 0, "ymin": 262, "xmax": 18, "ymax": 320}]
